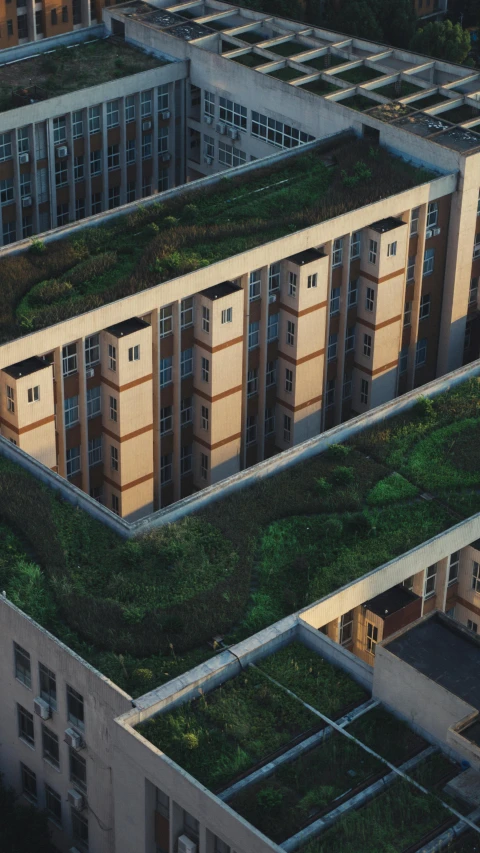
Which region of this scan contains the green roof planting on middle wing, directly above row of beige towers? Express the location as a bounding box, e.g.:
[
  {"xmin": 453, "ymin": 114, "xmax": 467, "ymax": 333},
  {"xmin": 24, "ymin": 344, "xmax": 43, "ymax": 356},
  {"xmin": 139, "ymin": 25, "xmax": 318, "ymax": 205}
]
[{"xmin": 0, "ymin": 139, "xmax": 432, "ymax": 341}]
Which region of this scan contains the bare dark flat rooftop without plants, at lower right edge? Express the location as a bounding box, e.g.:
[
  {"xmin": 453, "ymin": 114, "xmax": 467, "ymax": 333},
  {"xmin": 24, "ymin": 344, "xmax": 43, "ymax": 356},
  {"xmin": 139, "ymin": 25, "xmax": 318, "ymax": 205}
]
[{"xmin": 387, "ymin": 613, "xmax": 480, "ymax": 711}]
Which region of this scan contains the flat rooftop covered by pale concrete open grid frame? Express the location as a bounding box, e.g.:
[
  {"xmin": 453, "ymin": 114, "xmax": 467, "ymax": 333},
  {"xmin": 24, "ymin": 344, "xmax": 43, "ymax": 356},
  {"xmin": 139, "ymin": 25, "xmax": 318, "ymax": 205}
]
[{"xmin": 112, "ymin": 0, "xmax": 480, "ymax": 152}]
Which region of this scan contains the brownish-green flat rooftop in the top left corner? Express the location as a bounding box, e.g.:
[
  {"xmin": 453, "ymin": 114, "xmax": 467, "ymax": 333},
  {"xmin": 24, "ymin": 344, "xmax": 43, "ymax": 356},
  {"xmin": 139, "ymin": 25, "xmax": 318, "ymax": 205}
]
[{"xmin": 0, "ymin": 37, "xmax": 167, "ymax": 112}]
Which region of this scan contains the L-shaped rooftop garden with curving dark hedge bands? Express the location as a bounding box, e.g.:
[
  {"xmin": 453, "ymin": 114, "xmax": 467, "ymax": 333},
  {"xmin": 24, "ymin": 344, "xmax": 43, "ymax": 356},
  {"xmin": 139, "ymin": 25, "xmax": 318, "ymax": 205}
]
[{"xmin": 0, "ymin": 379, "xmax": 480, "ymax": 701}]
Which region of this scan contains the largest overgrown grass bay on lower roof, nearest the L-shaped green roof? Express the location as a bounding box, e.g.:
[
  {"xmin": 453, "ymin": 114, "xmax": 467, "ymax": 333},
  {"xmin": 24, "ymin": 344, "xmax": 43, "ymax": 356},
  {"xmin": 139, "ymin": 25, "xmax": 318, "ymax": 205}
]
[{"xmin": 138, "ymin": 669, "xmax": 320, "ymax": 790}]
